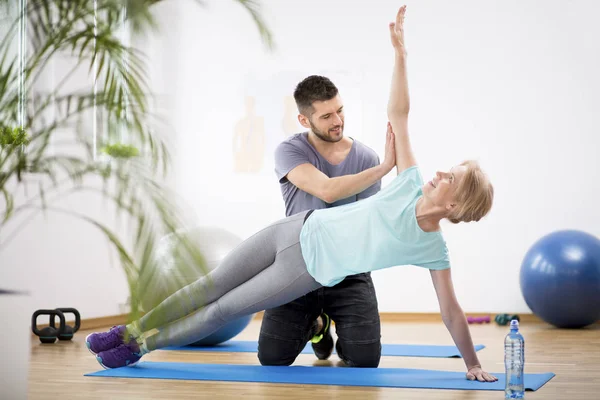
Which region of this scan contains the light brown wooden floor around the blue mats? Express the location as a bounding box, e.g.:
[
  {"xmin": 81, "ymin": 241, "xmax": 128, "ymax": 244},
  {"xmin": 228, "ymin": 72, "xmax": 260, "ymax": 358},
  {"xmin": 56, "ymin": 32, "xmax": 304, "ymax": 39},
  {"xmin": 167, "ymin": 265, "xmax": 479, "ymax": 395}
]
[{"xmin": 29, "ymin": 320, "xmax": 600, "ymax": 400}]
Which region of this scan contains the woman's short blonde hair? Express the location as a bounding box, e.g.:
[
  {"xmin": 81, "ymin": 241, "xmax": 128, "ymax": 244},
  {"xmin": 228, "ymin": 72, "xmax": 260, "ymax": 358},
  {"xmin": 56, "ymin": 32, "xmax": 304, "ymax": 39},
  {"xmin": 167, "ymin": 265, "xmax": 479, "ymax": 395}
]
[{"xmin": 448, "ymin": 160, "xmax": 494, "ymax": 224}]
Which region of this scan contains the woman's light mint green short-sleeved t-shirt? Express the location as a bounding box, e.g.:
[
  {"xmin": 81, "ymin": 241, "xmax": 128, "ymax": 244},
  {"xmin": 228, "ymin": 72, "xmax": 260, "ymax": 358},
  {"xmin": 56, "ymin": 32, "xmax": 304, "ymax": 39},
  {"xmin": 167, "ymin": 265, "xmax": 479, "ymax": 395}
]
[{"xmin": 300, "ymin": 166, "xmax": 450, "ymax": 286}]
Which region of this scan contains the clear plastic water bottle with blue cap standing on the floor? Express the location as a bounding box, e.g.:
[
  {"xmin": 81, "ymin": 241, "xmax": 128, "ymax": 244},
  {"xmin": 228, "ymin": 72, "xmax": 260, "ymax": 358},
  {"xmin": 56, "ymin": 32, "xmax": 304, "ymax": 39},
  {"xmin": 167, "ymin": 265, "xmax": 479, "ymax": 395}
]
[{"xmin": 504, "ymin": 319, "xmax": 525, "ymax": 399}]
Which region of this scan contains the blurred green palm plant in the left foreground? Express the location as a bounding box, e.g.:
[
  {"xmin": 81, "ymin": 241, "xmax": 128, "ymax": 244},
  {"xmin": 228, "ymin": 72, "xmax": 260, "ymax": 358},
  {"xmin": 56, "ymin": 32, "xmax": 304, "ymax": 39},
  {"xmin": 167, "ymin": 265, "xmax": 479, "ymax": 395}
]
[{"xmin": 0, "ymin": 0, "xmax": 272, "ymax": 399}]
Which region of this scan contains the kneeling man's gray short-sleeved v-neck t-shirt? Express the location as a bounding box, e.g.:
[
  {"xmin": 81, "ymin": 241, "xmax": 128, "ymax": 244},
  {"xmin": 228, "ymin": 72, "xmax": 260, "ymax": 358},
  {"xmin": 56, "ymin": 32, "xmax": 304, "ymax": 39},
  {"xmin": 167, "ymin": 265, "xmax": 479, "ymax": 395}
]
[{"xmin": 275, "ymin": 132, "xmax": 381, "ymax": 217}]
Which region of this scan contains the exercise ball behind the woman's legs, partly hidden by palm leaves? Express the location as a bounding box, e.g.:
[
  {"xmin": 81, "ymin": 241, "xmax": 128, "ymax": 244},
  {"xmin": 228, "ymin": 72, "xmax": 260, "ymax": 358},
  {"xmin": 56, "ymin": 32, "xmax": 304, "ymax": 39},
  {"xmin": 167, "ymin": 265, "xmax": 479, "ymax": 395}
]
[{"xmin": 139, "ymin": 226, "xmax": 254, "ymax": 346}]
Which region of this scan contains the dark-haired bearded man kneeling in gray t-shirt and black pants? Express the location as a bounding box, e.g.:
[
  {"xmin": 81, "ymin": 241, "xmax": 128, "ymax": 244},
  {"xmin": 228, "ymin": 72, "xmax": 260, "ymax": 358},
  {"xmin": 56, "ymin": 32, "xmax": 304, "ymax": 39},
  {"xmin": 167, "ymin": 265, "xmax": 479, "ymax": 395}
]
[{"xmin": 258, "ymin": 76, "xmax": 391, "ymax": 367}]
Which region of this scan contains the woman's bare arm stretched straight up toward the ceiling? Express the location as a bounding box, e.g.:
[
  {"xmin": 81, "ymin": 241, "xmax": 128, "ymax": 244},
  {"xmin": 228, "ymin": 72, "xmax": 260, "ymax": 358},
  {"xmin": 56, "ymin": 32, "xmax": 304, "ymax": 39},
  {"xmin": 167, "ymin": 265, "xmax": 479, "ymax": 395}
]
[{"xmin": 388, "ymin": 6, "xmax": 417, "ymax": 173}]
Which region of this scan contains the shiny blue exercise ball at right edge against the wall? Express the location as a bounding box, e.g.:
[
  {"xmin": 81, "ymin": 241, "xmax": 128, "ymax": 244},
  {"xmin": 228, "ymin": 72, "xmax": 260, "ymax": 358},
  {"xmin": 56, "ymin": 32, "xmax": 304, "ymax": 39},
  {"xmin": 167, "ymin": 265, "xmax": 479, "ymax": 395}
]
[{"xmin": 520, "ymin": 230, "xmax": 600, "ymax": 328}]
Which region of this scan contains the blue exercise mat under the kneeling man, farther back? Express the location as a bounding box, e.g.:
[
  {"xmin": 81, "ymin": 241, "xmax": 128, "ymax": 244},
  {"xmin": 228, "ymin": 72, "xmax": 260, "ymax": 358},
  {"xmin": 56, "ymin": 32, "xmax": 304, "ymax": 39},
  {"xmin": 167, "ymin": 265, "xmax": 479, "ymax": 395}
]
[{"xmin": 161, "ymin": 341, "xmax": 485, "ymax": 358}]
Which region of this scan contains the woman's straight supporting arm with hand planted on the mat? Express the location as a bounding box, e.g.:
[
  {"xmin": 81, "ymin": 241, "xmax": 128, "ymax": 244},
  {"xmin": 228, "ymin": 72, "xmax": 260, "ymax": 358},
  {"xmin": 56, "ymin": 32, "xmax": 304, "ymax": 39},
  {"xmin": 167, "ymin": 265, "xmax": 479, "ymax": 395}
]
[{"xmin": 431, "ymin": 268, "xmax": 498, "ymax": 382}]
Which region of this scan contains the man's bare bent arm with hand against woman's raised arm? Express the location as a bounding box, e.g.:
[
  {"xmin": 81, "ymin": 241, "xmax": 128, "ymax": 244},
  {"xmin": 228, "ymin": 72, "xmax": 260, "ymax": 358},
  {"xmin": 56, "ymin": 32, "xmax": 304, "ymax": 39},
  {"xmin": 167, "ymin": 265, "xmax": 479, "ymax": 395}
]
[{"xmin": 287, "ymin": 126, "xmax": 396, "ymax": 203}]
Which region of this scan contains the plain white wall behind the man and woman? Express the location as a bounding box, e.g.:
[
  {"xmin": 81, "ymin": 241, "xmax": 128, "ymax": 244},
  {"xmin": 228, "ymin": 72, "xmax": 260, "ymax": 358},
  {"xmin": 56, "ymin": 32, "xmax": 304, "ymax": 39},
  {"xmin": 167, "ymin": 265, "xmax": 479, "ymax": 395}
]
[{"xmin": 0, "ymin": 0, "xmax": 600, "ymax": 318}]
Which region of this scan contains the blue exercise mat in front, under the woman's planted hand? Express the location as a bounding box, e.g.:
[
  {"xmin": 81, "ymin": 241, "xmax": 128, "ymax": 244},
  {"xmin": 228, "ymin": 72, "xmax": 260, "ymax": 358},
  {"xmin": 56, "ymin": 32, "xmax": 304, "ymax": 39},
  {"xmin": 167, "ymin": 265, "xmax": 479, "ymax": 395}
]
[{"xmin": 85, "ymin": 361, "xmax": 554, "ymax": 390}]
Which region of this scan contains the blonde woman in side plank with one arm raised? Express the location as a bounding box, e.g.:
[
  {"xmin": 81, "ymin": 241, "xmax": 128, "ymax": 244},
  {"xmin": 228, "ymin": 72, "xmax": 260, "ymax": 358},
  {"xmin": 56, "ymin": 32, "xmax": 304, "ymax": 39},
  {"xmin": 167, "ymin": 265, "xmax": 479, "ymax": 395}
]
[{"xmin": 86, "ymin": 6, "xmax": 497, "ymax": 382}]
